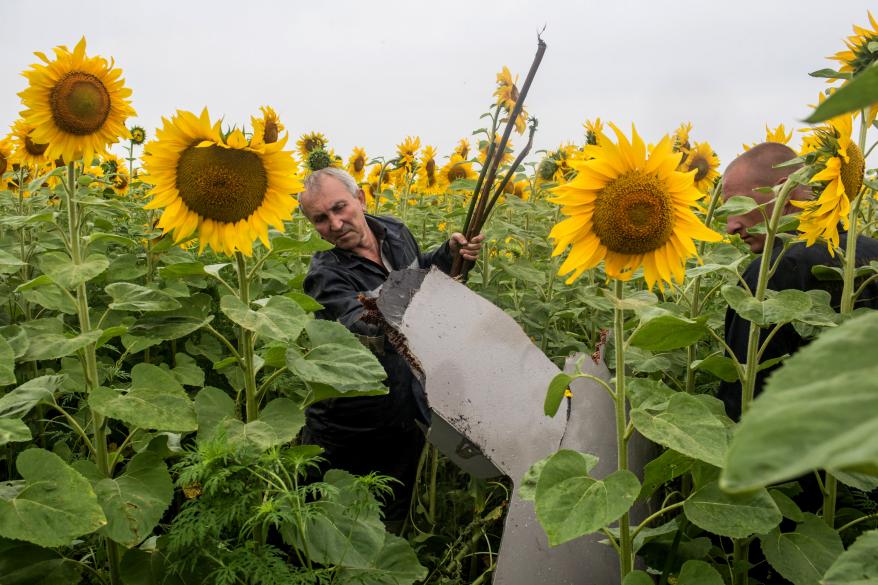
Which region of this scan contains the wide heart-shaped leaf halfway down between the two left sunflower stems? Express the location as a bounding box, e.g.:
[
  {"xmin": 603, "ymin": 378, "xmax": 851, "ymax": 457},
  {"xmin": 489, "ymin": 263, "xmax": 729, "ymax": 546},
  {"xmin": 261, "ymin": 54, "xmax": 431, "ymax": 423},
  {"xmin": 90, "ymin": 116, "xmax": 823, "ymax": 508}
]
[{"xmin": 88, "ymin": 363, "xmax": 198, "ymax": 431}]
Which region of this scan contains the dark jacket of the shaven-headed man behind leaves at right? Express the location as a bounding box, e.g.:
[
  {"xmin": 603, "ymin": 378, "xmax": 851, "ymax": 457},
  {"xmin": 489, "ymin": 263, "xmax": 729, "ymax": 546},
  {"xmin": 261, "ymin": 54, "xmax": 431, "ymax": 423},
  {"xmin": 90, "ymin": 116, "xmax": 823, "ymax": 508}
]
[{"xmin": 719, "ymin": 232, "xmax": 878, "ymax": 420}]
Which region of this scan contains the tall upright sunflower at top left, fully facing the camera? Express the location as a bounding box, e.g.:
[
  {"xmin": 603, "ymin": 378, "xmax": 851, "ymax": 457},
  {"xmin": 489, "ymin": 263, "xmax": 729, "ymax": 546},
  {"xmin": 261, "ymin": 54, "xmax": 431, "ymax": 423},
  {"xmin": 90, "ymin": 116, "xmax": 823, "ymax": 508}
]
[{"xmin": 18, "ymin": 37, "xmax": 136, "ymax": 162}]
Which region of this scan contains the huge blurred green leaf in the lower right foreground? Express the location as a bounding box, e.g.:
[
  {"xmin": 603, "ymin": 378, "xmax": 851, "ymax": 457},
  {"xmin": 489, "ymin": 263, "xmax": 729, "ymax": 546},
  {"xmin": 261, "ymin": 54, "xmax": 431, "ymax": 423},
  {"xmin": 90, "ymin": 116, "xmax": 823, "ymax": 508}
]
[{"xmin": 721, "ymin": 312, "xmax": 878, "ymax": 491}]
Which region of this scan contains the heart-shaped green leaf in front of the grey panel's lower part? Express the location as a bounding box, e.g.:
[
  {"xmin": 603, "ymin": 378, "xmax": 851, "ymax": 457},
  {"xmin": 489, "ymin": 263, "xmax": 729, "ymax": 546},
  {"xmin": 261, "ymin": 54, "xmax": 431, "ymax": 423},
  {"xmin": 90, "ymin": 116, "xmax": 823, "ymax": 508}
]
[{"xmin": 535, "ymin": 449, "xmax": 640, "ymax": 546}]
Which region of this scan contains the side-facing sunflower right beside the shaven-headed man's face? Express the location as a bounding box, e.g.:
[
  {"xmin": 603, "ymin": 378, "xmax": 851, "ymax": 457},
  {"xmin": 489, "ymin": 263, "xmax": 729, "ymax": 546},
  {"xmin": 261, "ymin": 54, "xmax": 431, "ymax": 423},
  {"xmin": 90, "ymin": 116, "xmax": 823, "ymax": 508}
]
[{"xmin": 792, "ymin": 114, "xmax": 866, "ymax": 255}]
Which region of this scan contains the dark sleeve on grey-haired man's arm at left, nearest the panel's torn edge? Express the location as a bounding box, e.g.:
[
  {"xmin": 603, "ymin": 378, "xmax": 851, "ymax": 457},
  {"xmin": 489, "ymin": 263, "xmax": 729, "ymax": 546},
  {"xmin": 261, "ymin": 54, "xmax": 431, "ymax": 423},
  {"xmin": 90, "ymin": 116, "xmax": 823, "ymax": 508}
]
[{"xmin": 303, "ymin": 268, "xmax": 381, "ymax": 337}]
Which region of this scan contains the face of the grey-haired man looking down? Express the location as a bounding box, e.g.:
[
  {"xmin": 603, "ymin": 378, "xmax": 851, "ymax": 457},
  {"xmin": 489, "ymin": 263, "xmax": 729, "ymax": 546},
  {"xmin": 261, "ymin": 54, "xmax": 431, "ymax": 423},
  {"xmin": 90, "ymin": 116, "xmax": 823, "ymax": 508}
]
[{"xmin": 301, "ymin": 176, "xmax": 369, "ymax": 250}]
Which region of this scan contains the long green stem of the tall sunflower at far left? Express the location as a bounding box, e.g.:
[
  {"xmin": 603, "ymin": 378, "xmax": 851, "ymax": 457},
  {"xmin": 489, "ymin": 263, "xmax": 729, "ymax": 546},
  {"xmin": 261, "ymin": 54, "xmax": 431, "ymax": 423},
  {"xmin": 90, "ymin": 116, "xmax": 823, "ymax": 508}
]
[{"xmin": 66, "ymin": 162, "xmax": 122, "ymax": 585}]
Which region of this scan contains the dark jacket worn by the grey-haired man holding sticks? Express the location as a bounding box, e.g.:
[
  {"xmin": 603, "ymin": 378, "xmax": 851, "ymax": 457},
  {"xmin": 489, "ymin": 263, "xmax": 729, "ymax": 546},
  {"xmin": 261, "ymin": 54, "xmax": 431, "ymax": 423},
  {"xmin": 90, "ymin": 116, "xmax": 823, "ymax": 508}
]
[{"xmin": 304, "ymin": 214, "xmax": 451, "ymax": 444}]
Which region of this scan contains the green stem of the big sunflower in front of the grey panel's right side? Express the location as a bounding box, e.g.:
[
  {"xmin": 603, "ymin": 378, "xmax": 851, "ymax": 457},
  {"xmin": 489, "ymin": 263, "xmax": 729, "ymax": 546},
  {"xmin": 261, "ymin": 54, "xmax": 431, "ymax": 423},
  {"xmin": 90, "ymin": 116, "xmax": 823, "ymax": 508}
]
[{"xmin": 613, "ymin": 280, "xmax": 634, "ymax": 579}]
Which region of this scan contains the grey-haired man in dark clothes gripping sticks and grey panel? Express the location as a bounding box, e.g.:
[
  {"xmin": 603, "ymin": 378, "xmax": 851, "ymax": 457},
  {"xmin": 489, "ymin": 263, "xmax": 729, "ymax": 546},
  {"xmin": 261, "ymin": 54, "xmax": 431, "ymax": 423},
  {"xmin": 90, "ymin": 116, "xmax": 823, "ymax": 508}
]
[{"xmin": 299, "ymin": 167, "xmax": 483, "ymax": 522}]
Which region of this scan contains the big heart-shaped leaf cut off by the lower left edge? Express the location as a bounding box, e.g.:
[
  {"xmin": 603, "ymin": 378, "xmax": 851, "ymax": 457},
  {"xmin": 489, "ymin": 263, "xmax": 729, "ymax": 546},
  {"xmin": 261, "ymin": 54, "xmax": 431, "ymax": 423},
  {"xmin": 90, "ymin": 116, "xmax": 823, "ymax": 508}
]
[{"xmin": 0, "ymin": 448, "xmax": 107, "ymax": 546}]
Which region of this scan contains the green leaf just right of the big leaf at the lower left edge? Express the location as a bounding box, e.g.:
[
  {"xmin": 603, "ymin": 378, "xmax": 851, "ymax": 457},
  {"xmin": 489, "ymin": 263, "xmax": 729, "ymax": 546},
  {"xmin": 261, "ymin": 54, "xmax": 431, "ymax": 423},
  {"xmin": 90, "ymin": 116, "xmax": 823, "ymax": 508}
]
[{"xmin": 94, "ymin": 452, "xmax": 174, "ymax": 547}]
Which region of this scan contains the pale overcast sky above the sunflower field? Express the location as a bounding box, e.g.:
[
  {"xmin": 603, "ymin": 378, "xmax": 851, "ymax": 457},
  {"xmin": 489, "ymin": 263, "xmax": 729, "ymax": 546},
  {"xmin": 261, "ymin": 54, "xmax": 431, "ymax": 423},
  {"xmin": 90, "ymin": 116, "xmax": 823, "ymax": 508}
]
[{"xmin": 0, "ymin": 0, "xmax": 871, "ymax": 171}]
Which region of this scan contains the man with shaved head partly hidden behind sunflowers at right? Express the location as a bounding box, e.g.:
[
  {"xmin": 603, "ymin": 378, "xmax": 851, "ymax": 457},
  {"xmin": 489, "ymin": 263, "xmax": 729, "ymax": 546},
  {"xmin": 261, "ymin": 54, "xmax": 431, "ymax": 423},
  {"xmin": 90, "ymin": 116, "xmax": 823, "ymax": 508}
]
[{"xmin": 719, "ymin": 142, "xmax": 878, "ymax": 420}]
